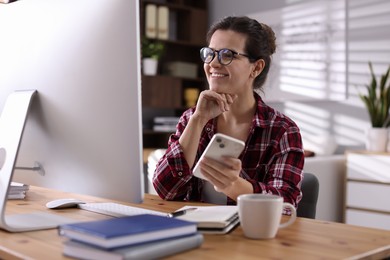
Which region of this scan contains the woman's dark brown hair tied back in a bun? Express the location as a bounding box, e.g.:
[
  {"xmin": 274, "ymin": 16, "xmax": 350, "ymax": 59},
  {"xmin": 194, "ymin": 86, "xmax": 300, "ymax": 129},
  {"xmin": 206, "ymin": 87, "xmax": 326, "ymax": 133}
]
[{"xmin": 206, "ymin": 16, "xmax": 276, "ymax": 89}]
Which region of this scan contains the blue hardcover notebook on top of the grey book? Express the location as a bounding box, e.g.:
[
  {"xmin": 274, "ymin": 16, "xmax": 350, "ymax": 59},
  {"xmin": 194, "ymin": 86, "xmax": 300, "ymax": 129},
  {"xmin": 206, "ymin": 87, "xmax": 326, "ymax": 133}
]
[{"xmin": 59, "ymin": 214, "xmax": 197, "ymax": 249}]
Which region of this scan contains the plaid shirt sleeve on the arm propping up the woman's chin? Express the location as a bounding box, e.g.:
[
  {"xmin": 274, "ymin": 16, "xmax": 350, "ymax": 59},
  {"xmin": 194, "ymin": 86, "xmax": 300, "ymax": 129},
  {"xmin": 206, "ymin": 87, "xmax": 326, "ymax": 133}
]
[{"xmin": 153, "ymin": 108, "xmax": 199, "ymax": 200}]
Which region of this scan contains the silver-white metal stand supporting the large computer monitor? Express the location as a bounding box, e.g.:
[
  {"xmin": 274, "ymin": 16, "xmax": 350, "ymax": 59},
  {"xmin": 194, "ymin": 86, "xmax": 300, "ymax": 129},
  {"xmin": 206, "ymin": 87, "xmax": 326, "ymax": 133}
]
[{"xmin": 0, "ymin": 90, "xmax": 75, "ymax": 232}]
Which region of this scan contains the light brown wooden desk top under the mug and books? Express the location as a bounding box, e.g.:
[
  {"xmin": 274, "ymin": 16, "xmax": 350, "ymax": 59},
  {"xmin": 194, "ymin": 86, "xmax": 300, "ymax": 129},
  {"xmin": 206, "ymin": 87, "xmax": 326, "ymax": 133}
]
[{"xmin": 0, "ymin": 187, "xmax": 390, "ymax": 260}]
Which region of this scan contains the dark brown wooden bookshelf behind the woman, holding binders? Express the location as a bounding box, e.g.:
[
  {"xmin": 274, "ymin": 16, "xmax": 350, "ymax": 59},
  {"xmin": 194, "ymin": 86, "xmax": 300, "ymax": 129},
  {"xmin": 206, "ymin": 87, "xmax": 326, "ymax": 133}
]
[{"xmin": 140, "ymin": 0, "xmax": 208, "ymax": 148}]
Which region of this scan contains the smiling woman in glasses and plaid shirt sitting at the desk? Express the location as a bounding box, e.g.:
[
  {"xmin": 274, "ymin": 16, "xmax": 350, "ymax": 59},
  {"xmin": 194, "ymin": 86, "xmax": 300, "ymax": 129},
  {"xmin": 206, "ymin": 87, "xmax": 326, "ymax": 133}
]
[{"xmin": 153, "ymin": 17, "xmax": 304, "ymax": 211}]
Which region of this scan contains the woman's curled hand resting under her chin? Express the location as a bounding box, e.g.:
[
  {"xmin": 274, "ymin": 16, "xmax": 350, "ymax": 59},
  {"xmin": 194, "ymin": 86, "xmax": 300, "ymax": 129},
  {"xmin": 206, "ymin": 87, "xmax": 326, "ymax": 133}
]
[{"xmin": 195, "ymin": 90, "xmax": 237, "ymax": 122}]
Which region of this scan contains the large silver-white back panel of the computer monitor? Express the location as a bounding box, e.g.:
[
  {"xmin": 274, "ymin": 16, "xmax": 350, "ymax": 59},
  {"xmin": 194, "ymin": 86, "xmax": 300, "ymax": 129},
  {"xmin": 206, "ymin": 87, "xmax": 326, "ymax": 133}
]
[{"xmin": 0, "ymin": 0, "xmax": 144, "ymax": 203}]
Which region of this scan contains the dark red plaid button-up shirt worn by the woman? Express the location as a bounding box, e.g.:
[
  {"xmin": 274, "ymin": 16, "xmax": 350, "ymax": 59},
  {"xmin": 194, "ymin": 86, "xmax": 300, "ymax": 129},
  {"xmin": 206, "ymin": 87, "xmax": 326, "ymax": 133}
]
[{"xmin": 153, "ymin": 93, "xmax": 304, "ymax": 207}]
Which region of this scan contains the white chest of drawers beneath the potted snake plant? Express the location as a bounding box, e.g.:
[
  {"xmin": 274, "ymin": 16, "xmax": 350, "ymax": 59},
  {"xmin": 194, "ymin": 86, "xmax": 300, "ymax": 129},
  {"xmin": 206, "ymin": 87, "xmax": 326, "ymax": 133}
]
[{"xmin": 344, "ymin": 151, "xmax": 390, "ymax": 230}]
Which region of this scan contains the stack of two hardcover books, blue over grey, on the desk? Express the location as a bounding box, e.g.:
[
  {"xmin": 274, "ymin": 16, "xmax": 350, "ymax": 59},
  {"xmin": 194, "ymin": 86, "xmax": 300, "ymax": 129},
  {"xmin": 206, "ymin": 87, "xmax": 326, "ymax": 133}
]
[{"xmin": 58, "ymin": 214, "xmax": 203, "ymax": 259}]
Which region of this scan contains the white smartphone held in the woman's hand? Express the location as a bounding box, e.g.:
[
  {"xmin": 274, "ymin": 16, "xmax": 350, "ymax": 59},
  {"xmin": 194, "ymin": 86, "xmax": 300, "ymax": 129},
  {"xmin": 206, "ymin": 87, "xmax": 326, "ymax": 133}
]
[{"xmin": 193, "ymin": 133, "xmax": 245, "ymax": 180}]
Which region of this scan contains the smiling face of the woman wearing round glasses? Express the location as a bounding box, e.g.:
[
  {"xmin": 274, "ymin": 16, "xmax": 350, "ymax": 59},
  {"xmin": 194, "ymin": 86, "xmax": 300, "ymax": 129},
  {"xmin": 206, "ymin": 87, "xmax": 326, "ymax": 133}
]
[{"xmin": 203, "ymin": 30, "xmax": 255, "ymax": 94}]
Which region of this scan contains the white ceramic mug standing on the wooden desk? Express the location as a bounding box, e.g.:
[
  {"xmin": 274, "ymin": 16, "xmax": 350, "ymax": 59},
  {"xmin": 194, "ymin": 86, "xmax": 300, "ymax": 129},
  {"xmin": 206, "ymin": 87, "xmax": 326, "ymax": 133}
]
[{"xmin": 237, "ymin": 193, "xmax": 297, "ymax": 239}]
